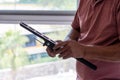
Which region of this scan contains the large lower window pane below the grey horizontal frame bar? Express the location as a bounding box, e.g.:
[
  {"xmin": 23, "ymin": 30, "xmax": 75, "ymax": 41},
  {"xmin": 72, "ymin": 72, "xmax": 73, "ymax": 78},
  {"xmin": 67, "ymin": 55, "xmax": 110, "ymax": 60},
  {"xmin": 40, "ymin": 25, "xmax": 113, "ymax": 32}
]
[{"xmin": 0, "ymin": 24, "xmax": 76, "ymax": 80}]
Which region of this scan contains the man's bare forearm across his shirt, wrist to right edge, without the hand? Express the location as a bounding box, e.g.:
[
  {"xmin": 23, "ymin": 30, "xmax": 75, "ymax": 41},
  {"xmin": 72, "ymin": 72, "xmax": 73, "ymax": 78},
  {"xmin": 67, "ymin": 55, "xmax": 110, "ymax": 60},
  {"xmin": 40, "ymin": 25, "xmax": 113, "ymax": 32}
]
[{"xmin": 85, "ymin": 43, "xmax": 120, "ymax": 61}]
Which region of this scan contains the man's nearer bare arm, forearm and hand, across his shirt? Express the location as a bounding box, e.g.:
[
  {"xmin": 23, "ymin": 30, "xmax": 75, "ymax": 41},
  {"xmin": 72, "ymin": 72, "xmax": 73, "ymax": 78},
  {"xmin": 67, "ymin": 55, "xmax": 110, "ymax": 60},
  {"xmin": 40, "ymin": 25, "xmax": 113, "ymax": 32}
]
[{"xmin": 55, "ymin": 40, "xmax": 120, "ymax": 61}]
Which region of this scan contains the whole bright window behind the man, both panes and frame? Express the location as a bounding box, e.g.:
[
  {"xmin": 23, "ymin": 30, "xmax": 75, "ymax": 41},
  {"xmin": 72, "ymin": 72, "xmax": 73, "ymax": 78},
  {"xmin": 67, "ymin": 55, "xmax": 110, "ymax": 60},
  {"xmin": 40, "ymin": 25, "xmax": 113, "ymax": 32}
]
[{"xmin": 0, "ymin": 0, "xmax": 79, "ymax": 80}]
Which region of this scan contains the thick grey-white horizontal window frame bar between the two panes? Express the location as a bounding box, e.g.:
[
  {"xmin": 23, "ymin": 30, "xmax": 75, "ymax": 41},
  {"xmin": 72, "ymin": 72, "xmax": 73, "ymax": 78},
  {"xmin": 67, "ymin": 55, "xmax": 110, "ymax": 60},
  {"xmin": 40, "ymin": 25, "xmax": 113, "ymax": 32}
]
[{"xmin": 0, "ymin": 0, "xmax": 80, "ymax": 24}]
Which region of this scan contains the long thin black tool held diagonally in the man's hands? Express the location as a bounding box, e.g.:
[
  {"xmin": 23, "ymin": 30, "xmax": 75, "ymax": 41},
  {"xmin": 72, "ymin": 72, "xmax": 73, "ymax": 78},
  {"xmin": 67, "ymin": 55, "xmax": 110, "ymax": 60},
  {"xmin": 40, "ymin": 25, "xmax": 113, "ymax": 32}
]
[{"xmin": 20, "ymin": 22, "xmax": 97, "ymax": 70}]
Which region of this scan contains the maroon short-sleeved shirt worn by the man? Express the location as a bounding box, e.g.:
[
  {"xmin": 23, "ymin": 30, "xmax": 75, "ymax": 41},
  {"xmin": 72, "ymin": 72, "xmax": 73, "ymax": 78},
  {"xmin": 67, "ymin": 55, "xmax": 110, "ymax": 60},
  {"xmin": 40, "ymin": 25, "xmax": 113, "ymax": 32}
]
[{"xmin": 72, "ymin": 0, "xmax": 120, "ymax": 80}]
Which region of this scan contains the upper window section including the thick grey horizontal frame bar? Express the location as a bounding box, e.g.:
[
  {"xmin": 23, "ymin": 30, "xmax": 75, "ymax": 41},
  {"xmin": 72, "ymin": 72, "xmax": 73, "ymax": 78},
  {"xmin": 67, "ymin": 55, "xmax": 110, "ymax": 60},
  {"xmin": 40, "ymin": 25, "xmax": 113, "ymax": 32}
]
[{"xmin": 0, "ymin": 0, "xmax": 77, "ymax": 24}]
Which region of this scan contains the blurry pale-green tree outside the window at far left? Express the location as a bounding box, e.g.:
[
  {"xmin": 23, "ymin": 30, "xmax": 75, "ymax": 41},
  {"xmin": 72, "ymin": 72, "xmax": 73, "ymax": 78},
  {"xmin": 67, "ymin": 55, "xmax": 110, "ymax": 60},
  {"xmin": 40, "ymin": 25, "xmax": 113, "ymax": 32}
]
[{"xmin": 0, "ymin": 30, "xmax": 28, "ymax": 69}]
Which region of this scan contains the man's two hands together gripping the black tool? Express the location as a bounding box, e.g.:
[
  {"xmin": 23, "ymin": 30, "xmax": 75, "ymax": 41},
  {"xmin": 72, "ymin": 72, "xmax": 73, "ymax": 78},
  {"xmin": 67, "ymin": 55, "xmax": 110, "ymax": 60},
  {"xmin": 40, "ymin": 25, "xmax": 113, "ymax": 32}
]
[{"xmin": 47, "ymin": 40, "xmax": 84, "ymax": 59}]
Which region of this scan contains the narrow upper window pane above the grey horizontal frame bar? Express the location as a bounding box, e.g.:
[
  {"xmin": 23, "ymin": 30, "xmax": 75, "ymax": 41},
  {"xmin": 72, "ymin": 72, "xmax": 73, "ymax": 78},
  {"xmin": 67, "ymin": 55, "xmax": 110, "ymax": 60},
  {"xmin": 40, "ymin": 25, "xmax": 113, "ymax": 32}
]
[{"xmin": 0, "ymin": 0, "xmax": 77, "ymax": 10}]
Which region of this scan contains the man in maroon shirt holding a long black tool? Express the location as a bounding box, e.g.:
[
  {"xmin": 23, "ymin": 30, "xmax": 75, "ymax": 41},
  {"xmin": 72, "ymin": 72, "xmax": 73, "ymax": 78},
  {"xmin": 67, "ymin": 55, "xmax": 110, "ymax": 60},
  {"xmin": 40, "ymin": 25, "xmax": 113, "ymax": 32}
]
[{"xmin": 47, "ymin": 0, "xmax": 120, "ymax": 80}]
